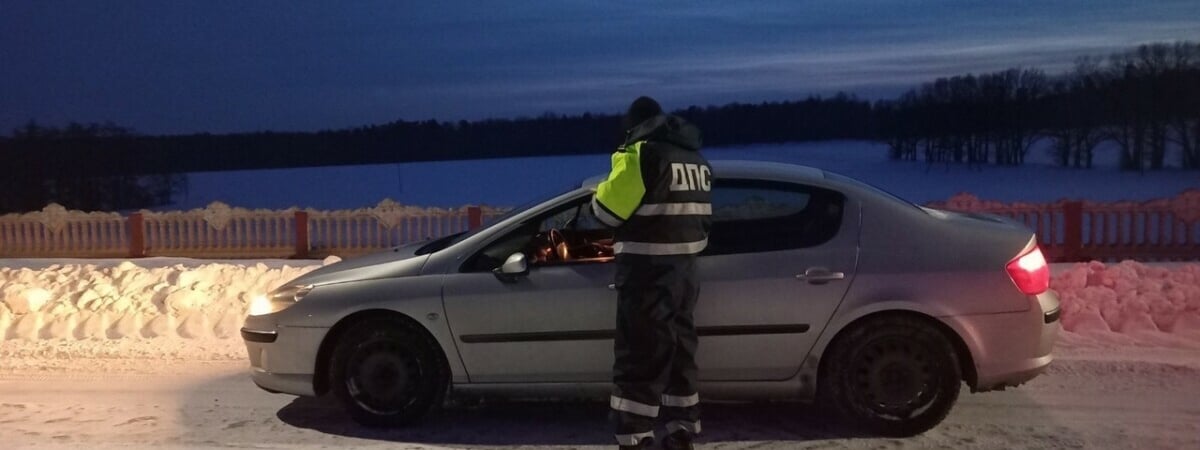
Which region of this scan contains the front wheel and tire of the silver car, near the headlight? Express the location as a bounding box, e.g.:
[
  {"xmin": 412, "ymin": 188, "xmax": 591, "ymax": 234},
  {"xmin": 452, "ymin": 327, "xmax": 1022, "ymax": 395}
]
[{"xmin": 330, "ymin": 319, "xmax": 449, "ymax": 427}]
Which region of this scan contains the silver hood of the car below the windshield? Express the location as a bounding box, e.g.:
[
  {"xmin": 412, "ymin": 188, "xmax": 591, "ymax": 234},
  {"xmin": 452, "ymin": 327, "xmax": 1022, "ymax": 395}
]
[{"xmin": 288, "ymin": 242, "xmax": 430, "ymax": 286}]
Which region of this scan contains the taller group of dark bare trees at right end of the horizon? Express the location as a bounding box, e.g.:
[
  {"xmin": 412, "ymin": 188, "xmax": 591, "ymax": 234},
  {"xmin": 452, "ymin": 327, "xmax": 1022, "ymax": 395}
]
[{"xmin": 872, "ymin": 42, "xmax": 1200, "ymax": 170}]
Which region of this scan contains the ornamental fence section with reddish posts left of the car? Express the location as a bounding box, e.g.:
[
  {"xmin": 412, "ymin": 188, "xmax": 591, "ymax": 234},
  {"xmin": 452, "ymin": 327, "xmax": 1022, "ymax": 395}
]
[{"xmin": 0, "ymin": 199, "xmax": 505, "ymax": 258}]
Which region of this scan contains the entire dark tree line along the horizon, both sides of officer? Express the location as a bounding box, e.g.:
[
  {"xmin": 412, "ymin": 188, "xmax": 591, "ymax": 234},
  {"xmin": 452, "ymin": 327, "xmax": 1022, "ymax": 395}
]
[{"xmin": 0, "ymin": 42, "xmax": 1200, "ymax": 212}]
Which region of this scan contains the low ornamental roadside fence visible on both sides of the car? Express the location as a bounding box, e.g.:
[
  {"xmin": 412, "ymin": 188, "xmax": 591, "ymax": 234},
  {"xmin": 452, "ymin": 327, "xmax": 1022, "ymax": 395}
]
[{"xmin": 0, "ymin": 190, "xmax": 1200, "ymax": 262}]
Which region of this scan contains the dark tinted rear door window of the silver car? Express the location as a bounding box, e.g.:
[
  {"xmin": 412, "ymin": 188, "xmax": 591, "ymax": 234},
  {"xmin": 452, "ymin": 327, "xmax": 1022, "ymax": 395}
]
[{"xmin": 703, "ymin": 179, "xmax": 846, "ymax": 256}]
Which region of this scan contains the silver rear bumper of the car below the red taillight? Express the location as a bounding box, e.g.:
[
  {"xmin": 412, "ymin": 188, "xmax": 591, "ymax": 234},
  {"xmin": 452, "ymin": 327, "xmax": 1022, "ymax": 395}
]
[{"xmin": 943, "ymin": 290, "xmax": 1061, "ymax": 391}]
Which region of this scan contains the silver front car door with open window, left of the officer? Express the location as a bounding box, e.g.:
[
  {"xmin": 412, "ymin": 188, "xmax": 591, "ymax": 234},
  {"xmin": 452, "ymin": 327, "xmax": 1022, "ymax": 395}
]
[{"xmin": 443, "ymin": 196, "xmax": 617, "ymax": 383}]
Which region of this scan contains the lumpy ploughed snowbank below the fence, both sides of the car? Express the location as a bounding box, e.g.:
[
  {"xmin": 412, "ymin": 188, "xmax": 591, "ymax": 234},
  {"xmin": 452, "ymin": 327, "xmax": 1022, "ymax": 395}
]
[{"xmin": 0, "ymin": 258, "xmax": 1200, "ymax": 370}]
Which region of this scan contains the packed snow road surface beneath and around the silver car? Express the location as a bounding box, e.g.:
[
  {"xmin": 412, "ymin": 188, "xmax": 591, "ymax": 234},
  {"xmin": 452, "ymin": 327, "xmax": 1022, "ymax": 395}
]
[{"xmin": 0, "ymin": 347, "xmax": 1200, "ymax": 449}]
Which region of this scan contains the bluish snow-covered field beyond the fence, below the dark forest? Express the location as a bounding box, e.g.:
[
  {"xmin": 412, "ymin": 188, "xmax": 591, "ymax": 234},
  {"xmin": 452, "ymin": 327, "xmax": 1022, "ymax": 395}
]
[{"xmin": 171, "ymin": 142, "xmax": 1200, "ymax": 210}]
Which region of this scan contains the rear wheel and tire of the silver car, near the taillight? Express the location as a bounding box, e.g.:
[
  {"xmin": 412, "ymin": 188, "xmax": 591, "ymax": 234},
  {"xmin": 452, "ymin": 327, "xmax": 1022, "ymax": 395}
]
[{"xmin": 817, "ymin": 316, "xmax": 962, "ymax": 437}]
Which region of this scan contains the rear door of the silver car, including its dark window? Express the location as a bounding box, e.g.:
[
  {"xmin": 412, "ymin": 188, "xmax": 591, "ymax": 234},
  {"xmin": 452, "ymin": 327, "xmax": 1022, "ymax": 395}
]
[{"xmin": 696, "ymin": 179, "xmax": 858, "ymax": 380}]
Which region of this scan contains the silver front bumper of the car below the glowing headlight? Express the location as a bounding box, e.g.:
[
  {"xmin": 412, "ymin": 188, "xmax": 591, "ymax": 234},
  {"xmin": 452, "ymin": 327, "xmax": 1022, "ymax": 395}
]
[{"xmin": 241, "ymin": 319, "xmax": 329, "ymax": 396}]
